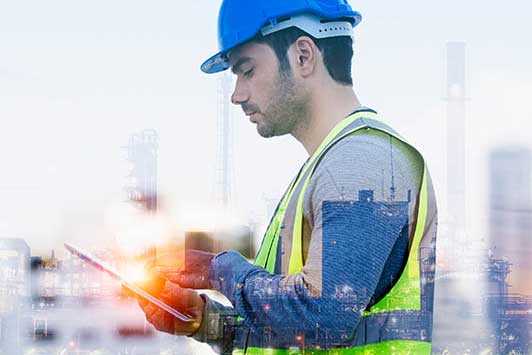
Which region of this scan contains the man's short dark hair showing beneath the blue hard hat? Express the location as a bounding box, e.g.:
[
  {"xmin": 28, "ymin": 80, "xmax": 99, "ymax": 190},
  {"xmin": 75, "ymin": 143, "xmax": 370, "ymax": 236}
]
[{"xmin": 254, "ymin": 27, "xmax": 353, "ymax": 85}]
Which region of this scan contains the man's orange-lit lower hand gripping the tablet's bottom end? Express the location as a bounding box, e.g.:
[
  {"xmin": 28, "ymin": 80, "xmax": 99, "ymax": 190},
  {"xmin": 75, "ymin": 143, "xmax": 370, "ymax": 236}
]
[{"xmin": 138, "ymin": 281, "xmax": 205, "ymax": 335}]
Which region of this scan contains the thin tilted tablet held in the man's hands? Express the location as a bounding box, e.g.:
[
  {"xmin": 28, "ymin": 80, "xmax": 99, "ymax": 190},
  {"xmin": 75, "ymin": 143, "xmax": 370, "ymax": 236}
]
[{"xmin": 64, "ymin": 243, "xmax": 194, "ymax": 322}]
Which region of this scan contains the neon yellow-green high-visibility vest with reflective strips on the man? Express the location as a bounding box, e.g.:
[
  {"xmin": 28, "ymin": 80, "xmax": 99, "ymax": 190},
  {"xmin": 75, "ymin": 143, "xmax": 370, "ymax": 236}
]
[{"xmin": 233, "ymin": 110, "xmax": 435, "ymax": 355}]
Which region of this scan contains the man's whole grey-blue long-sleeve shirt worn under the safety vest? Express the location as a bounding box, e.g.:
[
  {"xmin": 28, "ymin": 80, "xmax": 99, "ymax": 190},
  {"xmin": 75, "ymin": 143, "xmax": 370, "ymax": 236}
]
[{"xmin": 194, "ymin": 121, "xmax": 436, "ymax": 347}]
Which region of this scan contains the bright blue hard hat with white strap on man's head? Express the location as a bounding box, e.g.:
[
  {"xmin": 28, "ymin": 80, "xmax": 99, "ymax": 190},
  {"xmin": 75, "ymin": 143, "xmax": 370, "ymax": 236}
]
[{"xmin": 201, "ymin": 0, "xmax": 361, "ymax": 73}]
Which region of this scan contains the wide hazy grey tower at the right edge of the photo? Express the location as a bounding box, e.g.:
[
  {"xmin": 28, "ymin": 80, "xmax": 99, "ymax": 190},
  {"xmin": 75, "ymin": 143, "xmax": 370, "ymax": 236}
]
[{"xmin": 489, "ymin": 147, "xmax": 532, "ymax": 295}]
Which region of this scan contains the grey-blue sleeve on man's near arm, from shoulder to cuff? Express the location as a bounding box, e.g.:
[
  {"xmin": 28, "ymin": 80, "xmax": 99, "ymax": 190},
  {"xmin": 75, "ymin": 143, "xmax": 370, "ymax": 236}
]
[{"xmin": 206, "ymin": 129, "xmax": 419, "ymax": 345}]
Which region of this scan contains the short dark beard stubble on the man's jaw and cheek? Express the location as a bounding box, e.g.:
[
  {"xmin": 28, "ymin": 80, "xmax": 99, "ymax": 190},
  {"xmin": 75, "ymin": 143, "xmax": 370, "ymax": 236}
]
[{"xmin": 257, "ymin": 70, "xmax": 309, "ymax": 138}]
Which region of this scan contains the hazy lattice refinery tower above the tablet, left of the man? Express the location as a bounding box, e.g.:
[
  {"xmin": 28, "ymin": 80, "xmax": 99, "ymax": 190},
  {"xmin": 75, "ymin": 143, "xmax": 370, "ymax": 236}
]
[{"xmin": 125, "ymin": 129, "xmax": 159, "ymax": 213}]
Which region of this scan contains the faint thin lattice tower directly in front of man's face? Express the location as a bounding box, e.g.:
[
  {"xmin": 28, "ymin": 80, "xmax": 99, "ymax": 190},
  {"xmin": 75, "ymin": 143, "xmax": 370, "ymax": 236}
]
[{"xmin": 215, "ymin": 73, "xmax": 234, "ymax": 207}]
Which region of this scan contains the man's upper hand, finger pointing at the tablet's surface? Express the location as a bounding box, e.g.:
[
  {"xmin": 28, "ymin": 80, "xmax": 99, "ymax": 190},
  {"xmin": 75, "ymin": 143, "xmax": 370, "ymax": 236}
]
[{"xmin": 158, "ymin": 249, "xmax": 215, "ymax": 289}]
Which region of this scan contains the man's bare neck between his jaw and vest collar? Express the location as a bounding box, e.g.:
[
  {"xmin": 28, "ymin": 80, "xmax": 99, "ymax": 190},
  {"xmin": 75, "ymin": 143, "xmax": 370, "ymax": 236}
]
[{"xmin": 292, "ymin": 85, "xmax": 360, "ymax": 155}]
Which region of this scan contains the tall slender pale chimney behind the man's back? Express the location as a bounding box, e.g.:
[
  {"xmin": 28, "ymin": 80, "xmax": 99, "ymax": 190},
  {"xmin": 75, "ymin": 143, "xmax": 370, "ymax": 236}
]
[{"xmin": 446, "ymin": 42, "xmax": 467, "ymax": 231}]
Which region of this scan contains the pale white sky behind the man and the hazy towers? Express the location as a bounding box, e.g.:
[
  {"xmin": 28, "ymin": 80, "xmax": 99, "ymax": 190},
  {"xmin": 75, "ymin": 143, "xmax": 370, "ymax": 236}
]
[{"xmin": 0, "ymin": 0, "xmax": 532, "ymax": 253}]
